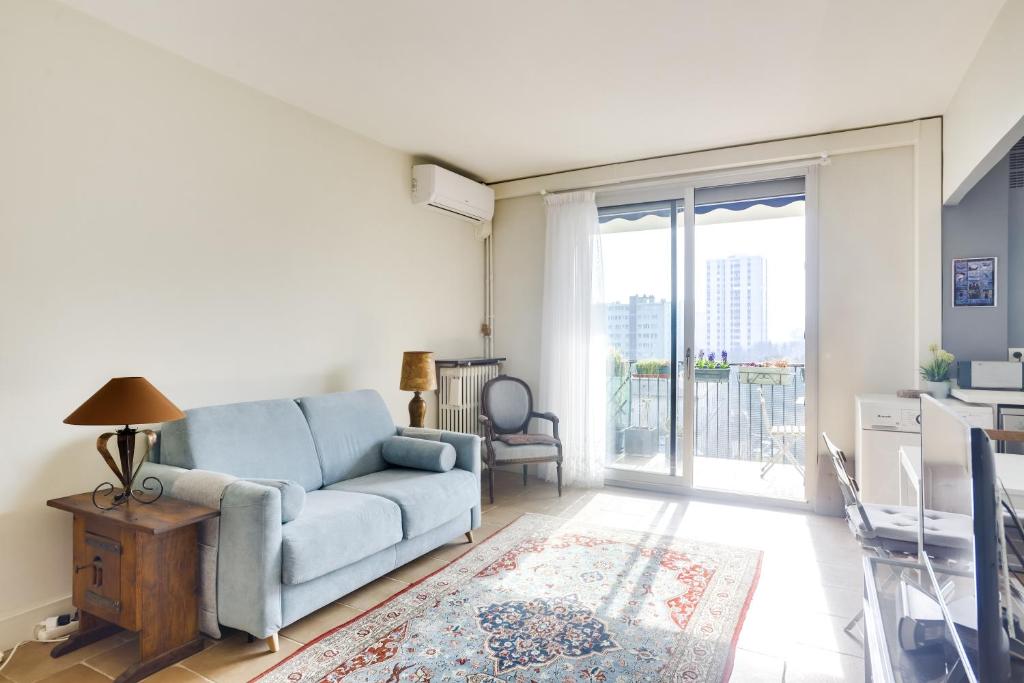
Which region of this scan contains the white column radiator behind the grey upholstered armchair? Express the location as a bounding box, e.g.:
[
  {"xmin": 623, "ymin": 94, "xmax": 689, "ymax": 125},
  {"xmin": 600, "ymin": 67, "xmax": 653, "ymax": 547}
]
[{"xmin": 437, "ymin": 358, "xmax": 505, "ymax": 436}]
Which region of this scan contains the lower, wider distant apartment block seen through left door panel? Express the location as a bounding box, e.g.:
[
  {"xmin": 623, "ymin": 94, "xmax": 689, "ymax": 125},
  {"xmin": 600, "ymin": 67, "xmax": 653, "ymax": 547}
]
[{"xmin": 606, "ymin": 296, "xmax": 672, "ymax": 360}]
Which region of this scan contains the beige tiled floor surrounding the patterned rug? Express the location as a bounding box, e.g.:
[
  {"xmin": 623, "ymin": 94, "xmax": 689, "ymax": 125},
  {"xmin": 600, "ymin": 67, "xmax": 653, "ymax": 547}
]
[{"xmin": 0, "ymin": 472, "xmax": 864, "ymax": 683}]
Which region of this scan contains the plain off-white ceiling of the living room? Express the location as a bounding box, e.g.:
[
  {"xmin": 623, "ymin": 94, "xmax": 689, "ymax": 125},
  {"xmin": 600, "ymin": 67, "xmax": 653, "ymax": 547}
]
[{"xmin": 66, "ymin": 0, "xmax": 1002, "ymax": 181}]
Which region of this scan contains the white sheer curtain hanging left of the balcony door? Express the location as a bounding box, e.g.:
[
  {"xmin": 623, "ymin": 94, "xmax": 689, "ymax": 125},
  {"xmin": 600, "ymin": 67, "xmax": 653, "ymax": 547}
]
[{"xmin": 538, "ymin": 191, "xmax": 606, "ymax": 486}]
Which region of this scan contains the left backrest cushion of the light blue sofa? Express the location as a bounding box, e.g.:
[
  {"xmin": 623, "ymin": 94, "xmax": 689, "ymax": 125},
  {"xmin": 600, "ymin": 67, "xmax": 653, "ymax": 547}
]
[{"xmin": 160, "ymin": 398, "xmax": 324, "ymax": 490}]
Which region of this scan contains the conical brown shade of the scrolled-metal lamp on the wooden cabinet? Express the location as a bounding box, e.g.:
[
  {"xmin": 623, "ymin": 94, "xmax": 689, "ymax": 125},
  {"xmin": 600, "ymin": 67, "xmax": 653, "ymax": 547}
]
[{"xmin": 65, "ymin": 377, "xmax": 185, "ymax": 426}]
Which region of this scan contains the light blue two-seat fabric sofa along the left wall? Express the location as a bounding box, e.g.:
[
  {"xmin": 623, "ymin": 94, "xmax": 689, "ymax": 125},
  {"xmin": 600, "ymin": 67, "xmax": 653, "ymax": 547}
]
[{"xmin": 139, "ymin": 391, "xmax": 480, "ymax": 649}]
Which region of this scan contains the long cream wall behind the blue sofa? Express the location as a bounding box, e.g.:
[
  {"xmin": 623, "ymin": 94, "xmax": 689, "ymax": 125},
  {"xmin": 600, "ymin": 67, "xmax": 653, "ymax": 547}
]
[{"xmin": 0, "ymin": 0, "xmax": 482, "ymax": 647}]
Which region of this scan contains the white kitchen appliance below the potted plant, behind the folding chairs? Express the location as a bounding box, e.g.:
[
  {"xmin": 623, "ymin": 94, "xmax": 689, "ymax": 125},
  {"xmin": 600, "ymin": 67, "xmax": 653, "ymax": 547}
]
[{"xmin": 854, "ymin": 394, "xmax": 993, "ymax": 505}]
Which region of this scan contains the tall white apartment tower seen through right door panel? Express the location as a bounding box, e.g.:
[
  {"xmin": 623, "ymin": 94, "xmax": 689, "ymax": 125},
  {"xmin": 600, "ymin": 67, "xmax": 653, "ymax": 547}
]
[{"xmin": 705, "ymin": 256, "xmax": 768, "ymax": 353}]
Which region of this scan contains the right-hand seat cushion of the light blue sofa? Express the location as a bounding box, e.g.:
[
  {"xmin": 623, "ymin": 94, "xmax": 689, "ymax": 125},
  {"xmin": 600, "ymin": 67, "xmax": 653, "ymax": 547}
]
[{"xmin": 327, "ymin": 467, "xmax": 480, "ymax": 539}]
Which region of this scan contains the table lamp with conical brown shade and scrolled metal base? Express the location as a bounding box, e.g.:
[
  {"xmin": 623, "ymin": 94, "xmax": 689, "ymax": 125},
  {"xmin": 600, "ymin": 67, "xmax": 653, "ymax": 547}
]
[{"xmin": 65, "ymin": 377, "xmax": 185, "ymax": 510}]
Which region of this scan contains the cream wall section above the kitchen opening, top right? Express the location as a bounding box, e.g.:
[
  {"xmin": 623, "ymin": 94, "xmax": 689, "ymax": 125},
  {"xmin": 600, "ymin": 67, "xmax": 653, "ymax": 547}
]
[{"xmin": 942, "ymin": 0, "xmax": 1024, "ymax": 204}]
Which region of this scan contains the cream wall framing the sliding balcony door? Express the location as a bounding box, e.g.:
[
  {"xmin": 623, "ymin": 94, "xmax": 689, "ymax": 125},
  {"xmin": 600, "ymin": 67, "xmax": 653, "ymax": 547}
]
[{"xmin": 494, "ymin": 120, "xmax": 941, "ymax": 511}]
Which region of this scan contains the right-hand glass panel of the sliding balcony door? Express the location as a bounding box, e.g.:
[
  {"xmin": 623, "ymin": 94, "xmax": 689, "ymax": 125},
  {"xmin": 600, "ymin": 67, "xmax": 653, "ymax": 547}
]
[{"xmin": 687, "ymin": 184, "xmax": 806, "ymax": 501}]
